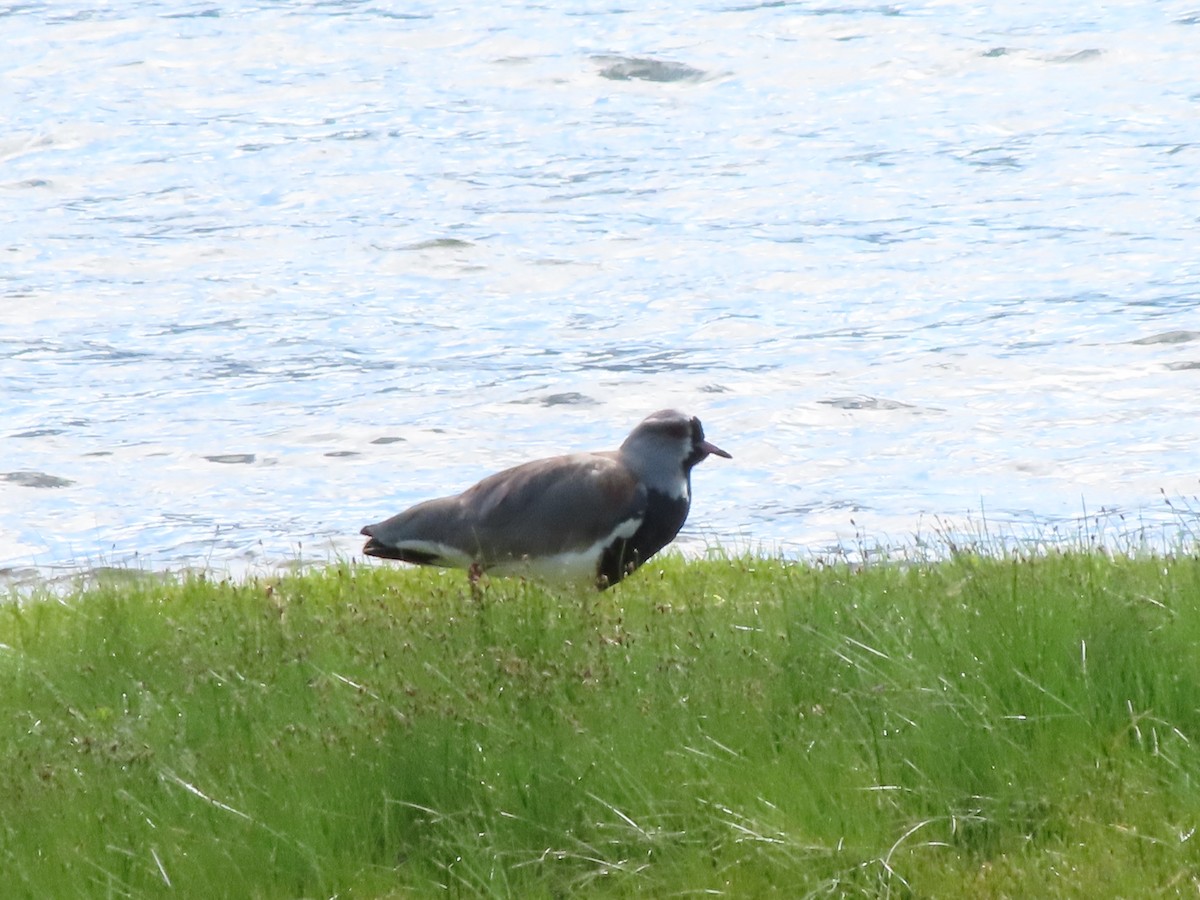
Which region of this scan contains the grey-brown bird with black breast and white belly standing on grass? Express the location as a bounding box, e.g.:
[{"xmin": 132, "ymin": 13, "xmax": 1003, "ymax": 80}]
[{"xmin": 361, "ymin": 409, "xmax": 733, "ymax": 590}]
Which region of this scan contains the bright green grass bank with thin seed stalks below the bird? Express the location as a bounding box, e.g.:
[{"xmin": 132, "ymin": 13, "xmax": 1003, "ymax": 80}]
[{"xmin": 0, "ymin": 552, "xmax": 1200, "ymax": 898}]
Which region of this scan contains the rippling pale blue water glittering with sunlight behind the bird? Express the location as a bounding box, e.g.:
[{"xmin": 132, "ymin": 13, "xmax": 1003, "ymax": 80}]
[{"xmin": 0, "ymin": 0, "xmax": 1200, "ymax": 585}]
